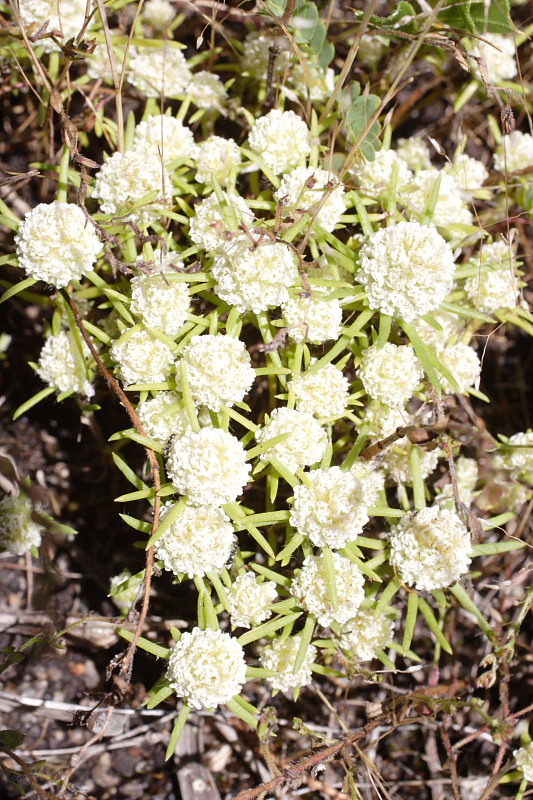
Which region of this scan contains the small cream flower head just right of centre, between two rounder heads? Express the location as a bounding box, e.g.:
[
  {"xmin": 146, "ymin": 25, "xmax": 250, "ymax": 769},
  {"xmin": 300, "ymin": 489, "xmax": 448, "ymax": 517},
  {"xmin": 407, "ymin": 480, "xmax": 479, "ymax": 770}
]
[{"xmin": 289, "ymin": 364, "xmax": 349, "ymax": 417}]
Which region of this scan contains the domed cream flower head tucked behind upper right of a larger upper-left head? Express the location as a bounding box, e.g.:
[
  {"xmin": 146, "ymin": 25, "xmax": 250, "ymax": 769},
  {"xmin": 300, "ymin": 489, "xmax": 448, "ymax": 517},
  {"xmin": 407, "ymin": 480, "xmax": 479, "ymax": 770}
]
[{"xmin": 133, "ymin": 114, "xmax": 198, "ymax": 164}]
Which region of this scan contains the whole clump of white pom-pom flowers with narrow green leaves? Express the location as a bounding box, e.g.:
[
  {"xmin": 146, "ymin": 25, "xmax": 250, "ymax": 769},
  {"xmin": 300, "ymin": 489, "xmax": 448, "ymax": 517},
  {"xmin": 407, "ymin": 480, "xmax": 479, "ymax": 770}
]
[{"xmin": 4, "ymin": 0, "xmax": 533, "ymax": 788}]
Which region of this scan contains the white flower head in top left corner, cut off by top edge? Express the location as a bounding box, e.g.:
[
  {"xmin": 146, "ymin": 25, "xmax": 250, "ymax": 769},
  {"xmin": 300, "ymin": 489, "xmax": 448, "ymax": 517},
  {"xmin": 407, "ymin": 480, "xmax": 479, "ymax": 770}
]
[{"xmin": 15, "ymin": 0, "xmax": 94, "ymax": 53}]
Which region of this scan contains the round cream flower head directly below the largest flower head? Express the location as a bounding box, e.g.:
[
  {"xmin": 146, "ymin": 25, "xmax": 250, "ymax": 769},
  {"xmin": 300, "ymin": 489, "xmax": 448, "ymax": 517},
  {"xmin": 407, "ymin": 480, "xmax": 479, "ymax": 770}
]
[{"xmin": 359, "ymin": 342, "xmax": 424, "ymax": 406}]
